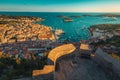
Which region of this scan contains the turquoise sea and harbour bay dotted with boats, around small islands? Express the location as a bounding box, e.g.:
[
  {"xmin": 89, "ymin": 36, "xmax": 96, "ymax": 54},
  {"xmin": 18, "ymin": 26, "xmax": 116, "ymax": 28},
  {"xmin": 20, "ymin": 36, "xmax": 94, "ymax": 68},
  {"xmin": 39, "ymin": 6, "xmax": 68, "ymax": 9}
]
[{"xmin": 0, "ymin": 12, "xmax": 120, "ymax": 42}]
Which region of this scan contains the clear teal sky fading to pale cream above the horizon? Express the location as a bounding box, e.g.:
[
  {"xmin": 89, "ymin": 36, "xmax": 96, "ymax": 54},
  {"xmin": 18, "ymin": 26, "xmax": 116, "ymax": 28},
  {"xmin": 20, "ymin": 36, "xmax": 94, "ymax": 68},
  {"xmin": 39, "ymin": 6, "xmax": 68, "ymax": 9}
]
[{"xmin": 0, "ymin": 0, "xmax": 120, "ymax": 12}]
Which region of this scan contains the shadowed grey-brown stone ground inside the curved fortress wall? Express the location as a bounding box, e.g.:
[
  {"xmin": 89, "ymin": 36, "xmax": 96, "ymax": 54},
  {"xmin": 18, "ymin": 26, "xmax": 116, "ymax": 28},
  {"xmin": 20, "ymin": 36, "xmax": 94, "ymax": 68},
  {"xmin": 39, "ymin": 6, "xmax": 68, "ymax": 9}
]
[{"xmin": 55, "ymin": 58, "xmax": 111, "ymax": 80}]
